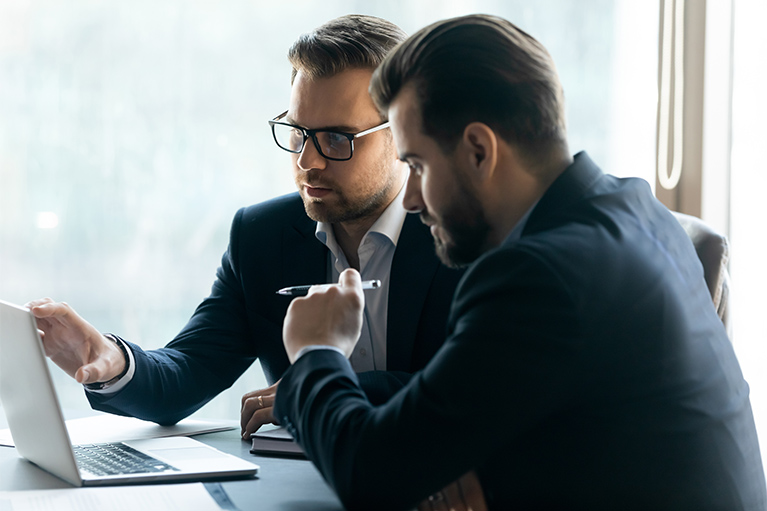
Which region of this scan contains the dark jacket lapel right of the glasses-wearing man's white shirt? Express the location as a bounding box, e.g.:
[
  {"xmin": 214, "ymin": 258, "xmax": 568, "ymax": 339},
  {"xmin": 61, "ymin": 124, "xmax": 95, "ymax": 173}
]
[{"xmin": 386, "ymin": 215, "xmax": 440, "ymax": 371}]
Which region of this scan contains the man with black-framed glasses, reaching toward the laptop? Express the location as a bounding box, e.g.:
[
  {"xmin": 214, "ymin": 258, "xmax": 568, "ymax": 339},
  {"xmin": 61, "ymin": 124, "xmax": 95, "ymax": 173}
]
[{"xmin": 28, "ymin": 15, "xmax": 461, "ymax": 438}]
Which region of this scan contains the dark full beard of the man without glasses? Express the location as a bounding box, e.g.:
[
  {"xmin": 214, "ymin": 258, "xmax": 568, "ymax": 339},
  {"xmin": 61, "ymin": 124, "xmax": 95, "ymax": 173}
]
[{"xmin": 421, "ymin": 169, "xmax": 491, "ymax": 268}]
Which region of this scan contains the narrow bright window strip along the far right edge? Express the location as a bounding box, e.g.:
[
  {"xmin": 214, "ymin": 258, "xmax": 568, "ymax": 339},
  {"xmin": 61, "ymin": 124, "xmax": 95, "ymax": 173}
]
[{"xmin": 730, "ymin": 0, "xmax": 767, "ymax": 459}]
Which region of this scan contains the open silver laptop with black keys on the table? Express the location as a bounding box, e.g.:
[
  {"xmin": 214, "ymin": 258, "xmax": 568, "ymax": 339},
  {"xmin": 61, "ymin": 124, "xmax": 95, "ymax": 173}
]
[{"xmin": 0, "ymin": 300, "xmax": 259, "ymax": 486}]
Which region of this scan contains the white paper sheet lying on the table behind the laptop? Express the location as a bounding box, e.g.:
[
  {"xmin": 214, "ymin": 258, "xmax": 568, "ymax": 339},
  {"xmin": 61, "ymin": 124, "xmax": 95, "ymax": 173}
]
[{"xmin": 0, "ymin": 414, "xmax": 240, "ymax": 446}]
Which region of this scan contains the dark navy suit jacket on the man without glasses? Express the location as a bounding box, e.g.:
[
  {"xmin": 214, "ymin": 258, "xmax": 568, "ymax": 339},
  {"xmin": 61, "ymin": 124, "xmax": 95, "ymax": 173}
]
[{"xmin": 275, "ymin": 154, "xmax": 767, "ymax": 511}]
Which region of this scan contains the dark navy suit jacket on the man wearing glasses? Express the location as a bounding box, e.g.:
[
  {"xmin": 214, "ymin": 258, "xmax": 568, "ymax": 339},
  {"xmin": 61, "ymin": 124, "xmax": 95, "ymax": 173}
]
[{"xmin": 88, "ymin": 193, "xmax": 462, "ymax": 424}]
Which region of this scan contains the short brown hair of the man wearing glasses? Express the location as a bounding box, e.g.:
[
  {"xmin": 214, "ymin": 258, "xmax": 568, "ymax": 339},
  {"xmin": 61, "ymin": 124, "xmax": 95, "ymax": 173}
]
[{"xmin": 288, "ymin": 14, "xmax": 407, "ymax": 83}]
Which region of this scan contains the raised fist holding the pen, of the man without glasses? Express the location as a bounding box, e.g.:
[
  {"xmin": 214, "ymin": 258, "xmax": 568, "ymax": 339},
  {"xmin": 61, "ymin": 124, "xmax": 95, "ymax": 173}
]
[{"xmin": 282, "ymin": 269, "xmax": 365, "ymax": 364}]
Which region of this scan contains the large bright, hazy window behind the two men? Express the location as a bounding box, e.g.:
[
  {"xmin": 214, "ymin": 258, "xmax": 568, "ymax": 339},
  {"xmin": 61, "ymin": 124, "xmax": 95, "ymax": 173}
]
[{"xmin": 0, "ymin": 0, "xmax": 659, "ymax": 418}]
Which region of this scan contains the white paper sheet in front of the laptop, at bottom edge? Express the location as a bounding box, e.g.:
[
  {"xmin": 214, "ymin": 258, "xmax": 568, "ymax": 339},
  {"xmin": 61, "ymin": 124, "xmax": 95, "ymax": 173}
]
[{"xmin": 0, "ymin": 483, "xmax": 221, "ymax": 511}]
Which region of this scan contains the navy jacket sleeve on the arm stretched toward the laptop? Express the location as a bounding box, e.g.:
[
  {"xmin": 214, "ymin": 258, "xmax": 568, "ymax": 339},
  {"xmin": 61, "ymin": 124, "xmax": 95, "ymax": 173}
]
[{"xmin": 86, "ymin": 206, "xmax": 258, "ymax": 425}]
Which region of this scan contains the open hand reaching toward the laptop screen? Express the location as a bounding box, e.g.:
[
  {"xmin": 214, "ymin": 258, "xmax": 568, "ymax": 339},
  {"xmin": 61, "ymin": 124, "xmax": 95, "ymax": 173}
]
[{"xmin": 26, "ymin": 298, "xmax": 125, "ymax": 384}]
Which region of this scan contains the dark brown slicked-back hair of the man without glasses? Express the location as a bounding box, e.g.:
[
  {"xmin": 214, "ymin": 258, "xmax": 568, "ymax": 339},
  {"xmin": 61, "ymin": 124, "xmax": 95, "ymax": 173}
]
[{"xmin": 370, "ymin": 15, "xmax": 567, "ymax": 161}]
